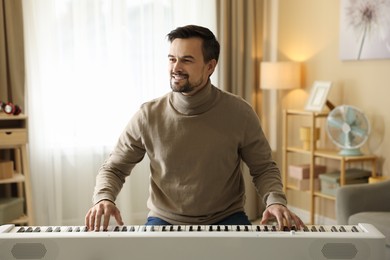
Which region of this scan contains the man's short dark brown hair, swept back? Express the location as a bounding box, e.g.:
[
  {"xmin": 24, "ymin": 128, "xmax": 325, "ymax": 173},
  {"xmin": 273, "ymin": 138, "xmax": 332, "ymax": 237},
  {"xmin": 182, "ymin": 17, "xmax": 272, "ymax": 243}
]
[{"xmin": 167, "ymin": 25, "xmax": 220, "ymax": 62}]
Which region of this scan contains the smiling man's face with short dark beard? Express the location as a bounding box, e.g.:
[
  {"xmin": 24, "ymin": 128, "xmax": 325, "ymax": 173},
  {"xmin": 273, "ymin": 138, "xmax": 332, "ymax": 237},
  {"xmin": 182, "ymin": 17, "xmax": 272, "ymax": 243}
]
[{"xmin": 168, "ymin": 38, "xmax": 216, "ymax": 96}]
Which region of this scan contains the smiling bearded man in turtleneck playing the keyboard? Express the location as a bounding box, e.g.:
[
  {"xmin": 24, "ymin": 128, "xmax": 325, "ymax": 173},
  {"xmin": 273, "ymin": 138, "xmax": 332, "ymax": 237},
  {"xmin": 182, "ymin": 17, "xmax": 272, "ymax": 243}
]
[{"xmin": 85, "ymin": 25, "xmax": 303, "ymax": 230}]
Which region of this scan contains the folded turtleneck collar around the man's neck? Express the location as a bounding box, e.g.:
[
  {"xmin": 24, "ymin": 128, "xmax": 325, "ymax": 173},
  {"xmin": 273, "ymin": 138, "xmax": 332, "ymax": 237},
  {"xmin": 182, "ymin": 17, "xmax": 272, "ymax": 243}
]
[{"xmin": 170, "ymin": 80, "xmax": 218, "ymax": 115}]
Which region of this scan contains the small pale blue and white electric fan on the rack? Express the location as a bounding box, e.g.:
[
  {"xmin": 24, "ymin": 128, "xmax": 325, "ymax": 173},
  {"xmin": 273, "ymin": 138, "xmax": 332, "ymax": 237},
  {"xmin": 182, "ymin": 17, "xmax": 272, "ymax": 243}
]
[{"xmin": 327, "ymin": 105, "xmax": 370, "ymax": 156}]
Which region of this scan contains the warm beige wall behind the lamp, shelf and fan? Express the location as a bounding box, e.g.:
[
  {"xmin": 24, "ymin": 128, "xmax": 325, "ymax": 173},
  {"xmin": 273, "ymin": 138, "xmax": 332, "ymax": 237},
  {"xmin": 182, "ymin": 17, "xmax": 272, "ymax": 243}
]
[{"xmin": 278, "ymin": 0, "xmax": 390, "ymax": 221}]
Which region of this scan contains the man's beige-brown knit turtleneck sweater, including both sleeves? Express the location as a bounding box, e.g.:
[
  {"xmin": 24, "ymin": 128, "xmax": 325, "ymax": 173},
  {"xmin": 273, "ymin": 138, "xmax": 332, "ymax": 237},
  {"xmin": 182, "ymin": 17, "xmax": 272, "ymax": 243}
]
[{"xmin": 93, "ymin": 83, "xmax": 286, "ymax": 224}]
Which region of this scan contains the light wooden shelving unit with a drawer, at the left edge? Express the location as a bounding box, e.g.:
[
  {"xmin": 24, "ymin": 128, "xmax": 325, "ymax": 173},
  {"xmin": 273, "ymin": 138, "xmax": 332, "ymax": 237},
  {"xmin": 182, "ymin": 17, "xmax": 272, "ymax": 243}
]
[{"xmin": 0, "ymin": 112, "xmax": 34, "ymax": 225}]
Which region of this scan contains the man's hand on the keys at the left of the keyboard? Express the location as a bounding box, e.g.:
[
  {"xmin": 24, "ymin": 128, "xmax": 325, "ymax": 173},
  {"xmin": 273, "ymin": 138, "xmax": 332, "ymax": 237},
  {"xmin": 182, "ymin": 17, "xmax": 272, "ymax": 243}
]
[{"xmin": 85, "ymin": 200, "xmax": 123, "ymax": 231}]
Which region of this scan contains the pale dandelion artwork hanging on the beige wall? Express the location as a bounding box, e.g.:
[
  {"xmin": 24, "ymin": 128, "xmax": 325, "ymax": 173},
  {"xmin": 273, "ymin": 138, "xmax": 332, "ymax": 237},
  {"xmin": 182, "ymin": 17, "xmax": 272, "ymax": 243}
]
[{"xmin": 340, "ymin": 0, "xmax": 390, "ymax": 60}]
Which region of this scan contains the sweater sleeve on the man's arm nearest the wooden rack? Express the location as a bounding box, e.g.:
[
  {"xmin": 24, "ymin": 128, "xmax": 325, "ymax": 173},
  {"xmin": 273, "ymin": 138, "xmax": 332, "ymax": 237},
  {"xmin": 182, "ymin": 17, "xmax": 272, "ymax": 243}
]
[{"xmin": 240, "ymin": 105, "xmax": 287, "ymax": 207}]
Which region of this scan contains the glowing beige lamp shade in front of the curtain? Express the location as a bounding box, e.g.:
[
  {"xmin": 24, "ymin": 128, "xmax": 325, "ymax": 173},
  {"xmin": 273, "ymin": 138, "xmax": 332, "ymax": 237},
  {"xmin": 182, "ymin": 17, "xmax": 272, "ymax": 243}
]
[{"xmin": 260, "ymin": 61, "xmax": 301, "ymax": 89}]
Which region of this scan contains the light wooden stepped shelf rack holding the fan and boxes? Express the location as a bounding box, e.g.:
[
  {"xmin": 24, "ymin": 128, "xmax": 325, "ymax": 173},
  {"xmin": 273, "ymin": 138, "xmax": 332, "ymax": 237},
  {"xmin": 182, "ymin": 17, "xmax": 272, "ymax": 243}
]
[{"xmin": 282, "ymin": 110, "xmax": 376, "ymax": 224}]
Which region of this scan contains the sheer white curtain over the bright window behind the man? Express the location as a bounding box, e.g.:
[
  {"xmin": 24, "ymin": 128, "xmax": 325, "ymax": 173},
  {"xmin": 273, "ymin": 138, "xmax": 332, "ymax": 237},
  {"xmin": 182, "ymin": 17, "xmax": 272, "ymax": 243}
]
[{"xmin": 23, "ymin": 0, "xmax": 216, "ymax": 225}]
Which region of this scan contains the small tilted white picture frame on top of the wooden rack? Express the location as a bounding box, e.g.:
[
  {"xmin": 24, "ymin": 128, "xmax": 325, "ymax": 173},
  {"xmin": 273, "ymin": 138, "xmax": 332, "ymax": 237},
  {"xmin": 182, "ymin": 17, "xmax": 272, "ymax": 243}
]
[{"xmin": 305, "ymin": 81, "xmax": 332, "ymax": 112}]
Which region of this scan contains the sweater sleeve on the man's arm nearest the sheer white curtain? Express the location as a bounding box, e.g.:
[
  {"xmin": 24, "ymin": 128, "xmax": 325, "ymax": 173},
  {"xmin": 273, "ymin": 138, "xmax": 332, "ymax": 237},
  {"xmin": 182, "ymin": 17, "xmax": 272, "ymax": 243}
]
[{"xmin": 92, "ymin": 108, "xmax": 145, "ymax": 204}]
